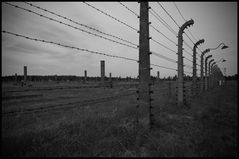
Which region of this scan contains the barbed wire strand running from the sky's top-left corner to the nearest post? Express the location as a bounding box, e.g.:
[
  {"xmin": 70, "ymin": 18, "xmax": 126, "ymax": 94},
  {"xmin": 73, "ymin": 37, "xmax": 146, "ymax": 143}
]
[{"xmin": 4, "ymin": 2, "xmax": 138, "ymax": 49}]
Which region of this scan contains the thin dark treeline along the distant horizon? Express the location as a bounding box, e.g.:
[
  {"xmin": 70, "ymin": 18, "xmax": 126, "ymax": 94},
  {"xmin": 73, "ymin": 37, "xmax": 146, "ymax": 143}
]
[{"xmin": 2, "ymin": 75, "xmax": 200, "ymax": 82}]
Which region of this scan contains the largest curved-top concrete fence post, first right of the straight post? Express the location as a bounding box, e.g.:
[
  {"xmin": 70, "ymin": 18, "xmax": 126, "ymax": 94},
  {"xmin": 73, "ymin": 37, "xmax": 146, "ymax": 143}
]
[{"xmin": 177, "ymin": 19, "xmax": 194, "ymax": 106}]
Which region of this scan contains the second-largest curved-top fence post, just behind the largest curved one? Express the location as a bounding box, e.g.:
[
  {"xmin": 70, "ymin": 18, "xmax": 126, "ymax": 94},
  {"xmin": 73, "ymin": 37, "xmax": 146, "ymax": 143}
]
[{"xmin": 193, "ymin": 39, "xmax": 205, "ymax": 96}]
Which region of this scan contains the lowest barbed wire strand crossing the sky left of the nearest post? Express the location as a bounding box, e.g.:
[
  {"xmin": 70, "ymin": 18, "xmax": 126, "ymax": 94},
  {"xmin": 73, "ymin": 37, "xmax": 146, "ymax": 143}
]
[{"xmin": 2, "ymin": 30, "xmax": 138, "ymax": 62}]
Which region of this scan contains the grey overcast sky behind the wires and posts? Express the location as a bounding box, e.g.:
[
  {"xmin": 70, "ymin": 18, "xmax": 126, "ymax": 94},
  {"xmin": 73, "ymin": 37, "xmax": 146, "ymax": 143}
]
[{"xmin": 2, "ymin": 2, "xmax": 238, "ymax": 77}]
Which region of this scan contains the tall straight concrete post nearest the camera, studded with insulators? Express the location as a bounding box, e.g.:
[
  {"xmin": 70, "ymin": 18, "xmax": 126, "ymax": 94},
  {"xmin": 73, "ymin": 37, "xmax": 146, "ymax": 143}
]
[{"xmin": 137, "ymin": 2, "xmax": 153, "ymax": 128}]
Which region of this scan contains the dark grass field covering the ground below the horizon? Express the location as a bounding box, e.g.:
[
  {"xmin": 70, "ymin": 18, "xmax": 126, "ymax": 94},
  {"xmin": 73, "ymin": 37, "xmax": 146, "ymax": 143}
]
[{"xmin": 2, "ymin": 81, "xmax": 238, "ymax": 157}]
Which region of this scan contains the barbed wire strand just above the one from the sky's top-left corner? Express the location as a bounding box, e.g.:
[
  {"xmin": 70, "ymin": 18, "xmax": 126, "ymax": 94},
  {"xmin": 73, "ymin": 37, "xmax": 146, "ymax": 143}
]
[{"xmin": 24, "ymin": 2, "xmax": 137, "ymax": 46}]
